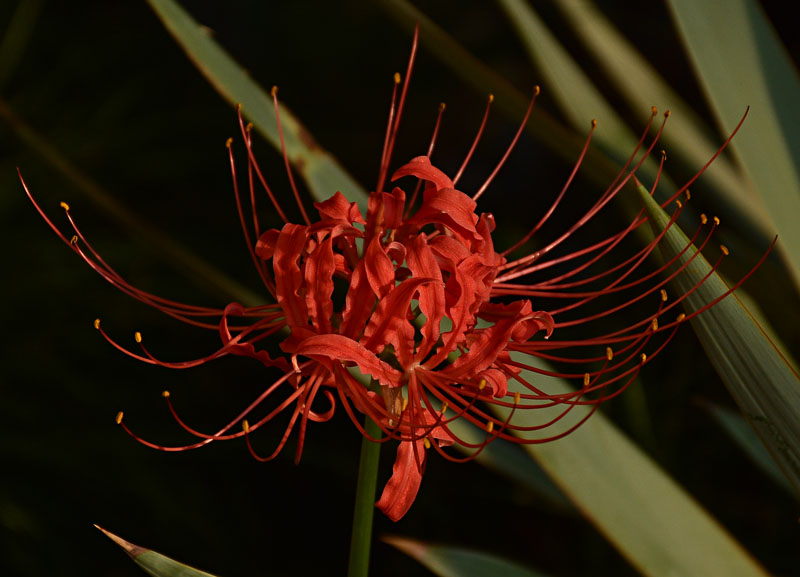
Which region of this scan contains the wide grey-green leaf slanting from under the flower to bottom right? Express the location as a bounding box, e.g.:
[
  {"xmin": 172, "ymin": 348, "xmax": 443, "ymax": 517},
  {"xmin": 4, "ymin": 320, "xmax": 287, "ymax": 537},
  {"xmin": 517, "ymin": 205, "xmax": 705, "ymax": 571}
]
[{"xmin": 490, "ymin": 353, "xmax": 767, "ymax": 577}]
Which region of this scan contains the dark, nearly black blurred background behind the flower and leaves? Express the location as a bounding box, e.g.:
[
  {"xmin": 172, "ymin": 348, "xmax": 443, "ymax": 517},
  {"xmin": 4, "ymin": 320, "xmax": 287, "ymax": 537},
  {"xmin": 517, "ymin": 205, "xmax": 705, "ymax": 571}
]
[{"xmin": 0, "ymin": 0, "xmax": 800, "ymax": 577}]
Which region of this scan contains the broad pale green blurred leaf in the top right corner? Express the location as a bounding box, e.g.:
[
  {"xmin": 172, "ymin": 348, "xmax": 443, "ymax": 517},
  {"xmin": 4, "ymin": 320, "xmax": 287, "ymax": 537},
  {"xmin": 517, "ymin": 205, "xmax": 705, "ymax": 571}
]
[{"xmin": 668, "ymin": 0, "xmax": 800, "ymax": 283}]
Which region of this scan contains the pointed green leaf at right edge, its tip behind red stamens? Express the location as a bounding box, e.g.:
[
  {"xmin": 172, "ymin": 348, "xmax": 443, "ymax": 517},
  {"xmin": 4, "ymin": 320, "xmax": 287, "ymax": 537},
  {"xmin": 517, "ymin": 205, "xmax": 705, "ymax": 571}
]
[{"xmin": 639, "ymin": 187, "xmax": 800, "ymax": 500}]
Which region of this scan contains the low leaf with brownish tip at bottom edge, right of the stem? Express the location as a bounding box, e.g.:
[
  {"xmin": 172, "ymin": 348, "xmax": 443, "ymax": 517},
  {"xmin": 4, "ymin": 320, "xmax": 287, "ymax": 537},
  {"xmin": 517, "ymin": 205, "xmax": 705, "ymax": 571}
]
[{"xmin": 383, "ymin": 537, "xmax": 545, "ymax": 577}]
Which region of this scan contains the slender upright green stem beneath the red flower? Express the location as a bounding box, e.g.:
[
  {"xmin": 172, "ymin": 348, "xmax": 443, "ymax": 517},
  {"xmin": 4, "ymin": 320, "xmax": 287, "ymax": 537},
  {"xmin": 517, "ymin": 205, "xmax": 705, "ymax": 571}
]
[{"xmin": 347, "ymin": 417, "xmax": 381, "ymax": 577}]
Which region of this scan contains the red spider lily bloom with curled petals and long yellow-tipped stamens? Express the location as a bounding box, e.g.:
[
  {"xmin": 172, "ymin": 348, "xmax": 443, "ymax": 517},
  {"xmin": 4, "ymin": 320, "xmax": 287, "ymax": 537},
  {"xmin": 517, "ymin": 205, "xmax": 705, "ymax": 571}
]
[{"xmin": 23, "ymin": 29, "xmax": 764, "ymax": 520}]
